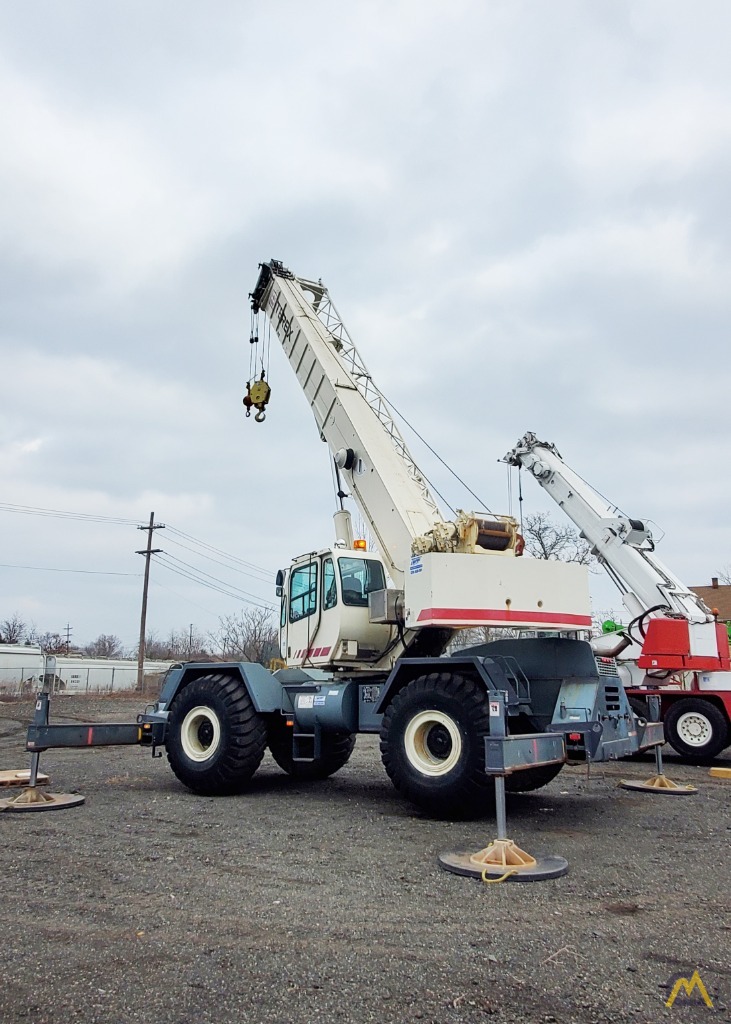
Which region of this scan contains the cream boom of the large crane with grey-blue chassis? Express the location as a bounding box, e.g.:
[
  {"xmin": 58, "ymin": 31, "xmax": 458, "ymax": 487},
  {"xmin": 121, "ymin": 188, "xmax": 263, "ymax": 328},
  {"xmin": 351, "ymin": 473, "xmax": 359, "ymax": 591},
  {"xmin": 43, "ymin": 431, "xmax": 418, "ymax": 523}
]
[{"xmin": 252, "ymin": 261, "xmax": 443, "ymax": 587}]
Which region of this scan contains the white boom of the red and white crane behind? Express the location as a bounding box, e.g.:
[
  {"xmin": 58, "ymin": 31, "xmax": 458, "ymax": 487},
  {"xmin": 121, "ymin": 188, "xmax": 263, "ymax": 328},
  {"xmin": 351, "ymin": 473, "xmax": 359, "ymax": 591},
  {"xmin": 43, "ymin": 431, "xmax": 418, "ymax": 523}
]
[{"xmin": 505, "ymin": 433, "xmax": 714, "ymax": 623}]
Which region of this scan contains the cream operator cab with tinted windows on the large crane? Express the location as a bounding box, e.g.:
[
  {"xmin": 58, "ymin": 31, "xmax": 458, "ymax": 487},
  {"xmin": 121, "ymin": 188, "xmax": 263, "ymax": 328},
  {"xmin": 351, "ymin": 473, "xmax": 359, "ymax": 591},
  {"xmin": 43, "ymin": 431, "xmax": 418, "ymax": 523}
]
[{"xmin": 276, "ymin": 547, "xmax": 395, "ymax": 669}]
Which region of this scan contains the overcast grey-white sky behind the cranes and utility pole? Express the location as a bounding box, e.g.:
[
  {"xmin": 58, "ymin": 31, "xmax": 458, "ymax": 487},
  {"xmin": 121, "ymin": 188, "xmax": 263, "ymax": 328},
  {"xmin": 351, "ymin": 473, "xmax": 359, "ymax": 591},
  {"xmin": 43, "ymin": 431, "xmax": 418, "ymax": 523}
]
[{"xmin": 0, "ymin": 0, "xmax": 731, "ymax": 645}]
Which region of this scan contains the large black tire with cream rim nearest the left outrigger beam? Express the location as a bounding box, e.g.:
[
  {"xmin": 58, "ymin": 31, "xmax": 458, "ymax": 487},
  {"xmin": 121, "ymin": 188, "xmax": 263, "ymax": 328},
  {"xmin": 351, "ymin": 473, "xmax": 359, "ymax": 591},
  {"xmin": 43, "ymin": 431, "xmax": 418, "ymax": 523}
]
[{"xmin": 166, "ymin": 675, "xmax": 266, "ymax": 797}]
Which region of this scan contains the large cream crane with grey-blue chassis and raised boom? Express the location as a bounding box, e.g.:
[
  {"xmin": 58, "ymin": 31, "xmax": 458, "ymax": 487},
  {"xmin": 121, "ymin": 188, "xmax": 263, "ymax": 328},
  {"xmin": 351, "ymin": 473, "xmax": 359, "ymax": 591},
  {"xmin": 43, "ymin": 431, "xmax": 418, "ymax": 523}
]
[{"xmin": 9, "ymin": 260, "xmax": 662, "ymax": 815}]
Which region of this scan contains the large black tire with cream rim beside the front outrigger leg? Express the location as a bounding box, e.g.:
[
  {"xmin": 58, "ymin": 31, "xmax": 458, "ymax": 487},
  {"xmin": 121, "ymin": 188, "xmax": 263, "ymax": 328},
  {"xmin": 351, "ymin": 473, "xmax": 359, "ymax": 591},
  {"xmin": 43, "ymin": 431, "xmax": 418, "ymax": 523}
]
[{"xmin": 381, "ymin": 673, "xmax": 495, "ymax": 817}]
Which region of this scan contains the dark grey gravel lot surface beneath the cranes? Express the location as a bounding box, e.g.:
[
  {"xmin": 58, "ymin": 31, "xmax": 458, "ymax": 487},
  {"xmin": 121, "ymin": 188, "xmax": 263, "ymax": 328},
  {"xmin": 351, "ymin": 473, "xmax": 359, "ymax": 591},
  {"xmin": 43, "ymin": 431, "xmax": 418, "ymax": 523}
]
[{"xmin": 0, "ymin": 697, "xmax": 731, "ymax": 1024}]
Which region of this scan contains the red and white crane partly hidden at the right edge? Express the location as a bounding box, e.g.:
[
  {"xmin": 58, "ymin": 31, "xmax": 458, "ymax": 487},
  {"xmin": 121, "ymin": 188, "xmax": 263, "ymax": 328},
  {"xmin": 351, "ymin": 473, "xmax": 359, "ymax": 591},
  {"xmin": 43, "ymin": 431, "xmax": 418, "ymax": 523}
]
[{"xmin": 505, "ymin": 433, "xmax": 731, "ymax": 759}]
